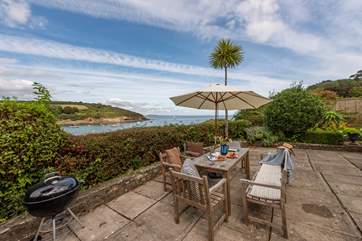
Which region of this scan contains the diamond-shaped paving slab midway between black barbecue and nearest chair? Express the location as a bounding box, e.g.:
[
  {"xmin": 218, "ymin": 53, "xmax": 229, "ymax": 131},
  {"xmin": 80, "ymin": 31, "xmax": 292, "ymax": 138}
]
[{"xmin": 107, "ymin": 191, "xmax": 156, "ymax": 220}]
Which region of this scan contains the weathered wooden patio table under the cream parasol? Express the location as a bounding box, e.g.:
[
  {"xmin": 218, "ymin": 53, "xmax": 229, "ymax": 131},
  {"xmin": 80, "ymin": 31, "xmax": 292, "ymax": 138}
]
[{"xmin": 193, "ymin": 145, "xmax": 250, "ymax": 216}]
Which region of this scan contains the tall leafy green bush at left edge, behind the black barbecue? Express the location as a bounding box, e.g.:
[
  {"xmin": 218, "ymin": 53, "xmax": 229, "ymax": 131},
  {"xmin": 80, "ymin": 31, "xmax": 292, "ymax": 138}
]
[{"xmin": 0, "ymin": 99, "xmax": 65, "ymax": 220}]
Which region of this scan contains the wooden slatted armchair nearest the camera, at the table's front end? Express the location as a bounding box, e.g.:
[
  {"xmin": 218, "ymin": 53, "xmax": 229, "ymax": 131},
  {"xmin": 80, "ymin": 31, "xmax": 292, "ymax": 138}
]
[{"xmin": 171, "ymin": 170, "xmax": 228, "ymax": 241}]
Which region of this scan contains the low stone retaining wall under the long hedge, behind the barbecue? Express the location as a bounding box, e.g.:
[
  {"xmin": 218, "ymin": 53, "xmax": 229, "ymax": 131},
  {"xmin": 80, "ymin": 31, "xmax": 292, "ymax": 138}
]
[{"xmin": 0, "ymin": 163, "xmax": 160, "ymax": 241}]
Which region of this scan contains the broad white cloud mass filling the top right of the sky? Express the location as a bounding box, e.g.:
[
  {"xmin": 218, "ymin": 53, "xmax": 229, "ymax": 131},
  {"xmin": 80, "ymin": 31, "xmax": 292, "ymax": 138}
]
[{"xmin": 27, "ymin": 0, "xmax": 362, "ymax": 74}]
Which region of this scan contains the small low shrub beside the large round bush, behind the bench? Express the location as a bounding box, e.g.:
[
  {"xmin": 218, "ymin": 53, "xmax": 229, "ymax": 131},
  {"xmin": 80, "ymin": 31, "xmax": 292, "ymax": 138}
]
[{"xmin": 245, "ymin": 126, "xmax": 281, "ymax": 146}]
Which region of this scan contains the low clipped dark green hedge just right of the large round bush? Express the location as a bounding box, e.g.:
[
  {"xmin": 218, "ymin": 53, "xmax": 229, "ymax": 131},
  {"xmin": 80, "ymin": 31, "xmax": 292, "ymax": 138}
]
[{"xmin": 304, "ymin": 128, "xmax": 344, "ymax": 145}]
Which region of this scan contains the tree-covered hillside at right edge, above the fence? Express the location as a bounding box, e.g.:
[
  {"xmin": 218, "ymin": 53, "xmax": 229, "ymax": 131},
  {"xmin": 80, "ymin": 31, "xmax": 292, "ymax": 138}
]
[{"xmin": 307, "ymin": 78, "xmax": 362, "ymax": 98}]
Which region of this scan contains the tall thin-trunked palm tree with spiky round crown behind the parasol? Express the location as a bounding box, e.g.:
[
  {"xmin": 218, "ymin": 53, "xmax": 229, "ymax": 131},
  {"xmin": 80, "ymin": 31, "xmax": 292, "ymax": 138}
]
[{"xmin": 209, "ymin": 39, "xmax": 244, "ymax": 137}]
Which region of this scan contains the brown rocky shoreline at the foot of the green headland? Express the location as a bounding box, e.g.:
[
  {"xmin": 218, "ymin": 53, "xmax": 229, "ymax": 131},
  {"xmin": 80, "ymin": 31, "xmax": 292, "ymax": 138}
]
[{"xmin": 57, "ymin": 116, "xmax": 147, "ymax": 126}]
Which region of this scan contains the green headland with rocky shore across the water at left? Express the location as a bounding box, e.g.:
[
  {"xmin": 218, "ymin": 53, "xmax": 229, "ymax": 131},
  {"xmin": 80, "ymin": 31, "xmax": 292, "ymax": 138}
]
[{"xmin": 52, "ymin": 101, "xmax": 146, "ymax": 125}]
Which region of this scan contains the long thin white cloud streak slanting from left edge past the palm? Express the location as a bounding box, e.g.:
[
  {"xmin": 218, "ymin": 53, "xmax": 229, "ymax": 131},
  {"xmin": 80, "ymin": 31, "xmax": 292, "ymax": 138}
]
[{"xmin": 0, "ymin": 34, "xmax": 285, "ymax": 89}]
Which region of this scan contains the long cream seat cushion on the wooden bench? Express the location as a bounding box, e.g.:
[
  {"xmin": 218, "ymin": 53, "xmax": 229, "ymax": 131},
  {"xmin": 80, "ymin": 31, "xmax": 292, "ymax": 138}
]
[{"xmin": 247, "ymin": 164, "xmax": 282, "ymax": 200}]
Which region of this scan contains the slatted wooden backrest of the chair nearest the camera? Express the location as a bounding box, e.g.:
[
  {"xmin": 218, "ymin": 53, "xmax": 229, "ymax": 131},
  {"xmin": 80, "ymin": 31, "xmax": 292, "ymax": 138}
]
[{"xmin": 171, "ymin": 170, "xmax": 210, "ymax": 209}]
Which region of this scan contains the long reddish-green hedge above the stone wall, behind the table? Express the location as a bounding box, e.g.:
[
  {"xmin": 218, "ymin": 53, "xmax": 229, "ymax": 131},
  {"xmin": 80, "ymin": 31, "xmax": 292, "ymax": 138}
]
[{"xmin": 57, "ymin": 121, "xmax": 250, "ymax": 188}]
